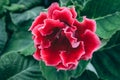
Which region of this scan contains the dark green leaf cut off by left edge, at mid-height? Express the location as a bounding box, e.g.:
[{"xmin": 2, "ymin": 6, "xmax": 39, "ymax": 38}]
[{"xmin": 0, "ymin": 18, "xmax": 7, "ymax": 54}]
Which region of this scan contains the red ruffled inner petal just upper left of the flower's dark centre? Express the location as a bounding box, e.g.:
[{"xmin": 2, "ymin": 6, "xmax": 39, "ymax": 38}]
[{"xmin": 39, "ymin": 19, "xmax": 65, "ymax": 36}]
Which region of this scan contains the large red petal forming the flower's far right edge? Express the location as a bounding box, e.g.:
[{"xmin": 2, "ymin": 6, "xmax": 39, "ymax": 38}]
[{"xmin": 81, "ymin": 30, "xmax": 101, "ymax": 60}]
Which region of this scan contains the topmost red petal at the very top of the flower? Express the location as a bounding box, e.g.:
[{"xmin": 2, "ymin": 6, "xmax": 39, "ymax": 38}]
[{"xmin": 48, "ymin": 2, "xmax": 60, "ymax": 18}]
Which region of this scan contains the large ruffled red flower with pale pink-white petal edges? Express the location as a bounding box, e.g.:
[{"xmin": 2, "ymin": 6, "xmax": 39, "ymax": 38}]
[{"xmin": 30, "ymin": 3, "xmax": 100, "ymax": 70}]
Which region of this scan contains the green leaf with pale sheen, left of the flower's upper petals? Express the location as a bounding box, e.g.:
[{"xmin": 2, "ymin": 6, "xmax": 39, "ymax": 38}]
[{"xmin": 10, "ymin": 7, "xmax": 43, "ymax": 29}]
